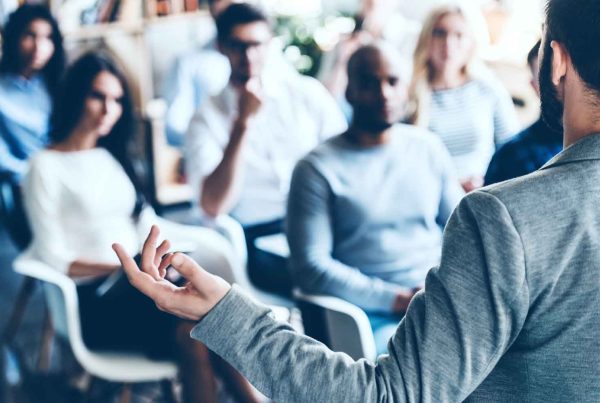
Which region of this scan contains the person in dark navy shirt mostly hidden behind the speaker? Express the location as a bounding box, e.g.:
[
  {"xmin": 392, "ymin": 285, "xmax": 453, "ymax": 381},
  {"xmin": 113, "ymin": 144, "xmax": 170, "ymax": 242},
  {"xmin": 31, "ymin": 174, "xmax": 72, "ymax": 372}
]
[{"xmin": 485, "ymin": 42, "xmax": 563, "ymax": 185}]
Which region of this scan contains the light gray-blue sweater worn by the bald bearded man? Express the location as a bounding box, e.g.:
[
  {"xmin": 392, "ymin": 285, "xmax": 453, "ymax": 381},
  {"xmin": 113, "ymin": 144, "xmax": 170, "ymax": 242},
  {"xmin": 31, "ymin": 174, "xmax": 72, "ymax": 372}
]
[{"xmin": 286, "ymin": 125, "xmax": 463, "ymax": 312}]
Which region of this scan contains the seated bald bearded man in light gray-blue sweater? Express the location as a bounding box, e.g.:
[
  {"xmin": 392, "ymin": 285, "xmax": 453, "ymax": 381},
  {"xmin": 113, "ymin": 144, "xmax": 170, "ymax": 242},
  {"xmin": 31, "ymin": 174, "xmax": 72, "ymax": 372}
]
[{"xmin": 286, "ymin": 45, "xmax": 463, "ymax": 353}]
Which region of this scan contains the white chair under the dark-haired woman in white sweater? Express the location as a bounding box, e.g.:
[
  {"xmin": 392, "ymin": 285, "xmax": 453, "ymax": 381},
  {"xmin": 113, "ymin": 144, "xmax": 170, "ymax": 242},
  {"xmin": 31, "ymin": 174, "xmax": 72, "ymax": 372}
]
[{"xmin": 13, "ymin": 255, "xmax": 177, "ymax": 398}]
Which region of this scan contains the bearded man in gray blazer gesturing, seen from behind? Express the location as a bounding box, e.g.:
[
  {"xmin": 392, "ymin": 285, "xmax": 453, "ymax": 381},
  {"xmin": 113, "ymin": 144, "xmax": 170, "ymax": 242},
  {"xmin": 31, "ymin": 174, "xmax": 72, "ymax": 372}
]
[{"xmin": 115, "ymin": 0, "xmax": 600, "ymax": 402}]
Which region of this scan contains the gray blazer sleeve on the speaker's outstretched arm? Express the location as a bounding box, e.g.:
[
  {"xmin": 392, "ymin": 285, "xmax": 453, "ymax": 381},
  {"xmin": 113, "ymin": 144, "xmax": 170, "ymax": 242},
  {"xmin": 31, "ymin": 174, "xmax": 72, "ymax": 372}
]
[{"xmin": 192, "ymin": 191, "xmax": 529, "ymax": 403}]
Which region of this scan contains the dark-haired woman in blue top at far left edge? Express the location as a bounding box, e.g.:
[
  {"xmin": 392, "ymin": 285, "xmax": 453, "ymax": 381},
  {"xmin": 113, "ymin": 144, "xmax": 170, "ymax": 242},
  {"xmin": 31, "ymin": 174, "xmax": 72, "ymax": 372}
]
[{"xmin": 0, "ymin": 4, "xmax": 65, "ymax": 183}]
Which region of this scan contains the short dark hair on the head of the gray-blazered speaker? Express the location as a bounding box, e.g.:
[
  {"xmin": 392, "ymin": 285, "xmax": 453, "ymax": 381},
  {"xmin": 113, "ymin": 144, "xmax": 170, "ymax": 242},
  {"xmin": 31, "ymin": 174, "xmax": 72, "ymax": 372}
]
[{"xmin": 544, "ymin": 0, "xmax": 600, "ymax": 94}]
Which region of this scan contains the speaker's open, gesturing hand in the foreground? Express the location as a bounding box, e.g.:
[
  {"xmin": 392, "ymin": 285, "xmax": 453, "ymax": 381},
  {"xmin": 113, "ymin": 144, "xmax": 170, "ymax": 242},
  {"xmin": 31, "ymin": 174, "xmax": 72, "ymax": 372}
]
[{"xmin": 113, "ymin": 226, "xmax": 231, "ymax": 321}]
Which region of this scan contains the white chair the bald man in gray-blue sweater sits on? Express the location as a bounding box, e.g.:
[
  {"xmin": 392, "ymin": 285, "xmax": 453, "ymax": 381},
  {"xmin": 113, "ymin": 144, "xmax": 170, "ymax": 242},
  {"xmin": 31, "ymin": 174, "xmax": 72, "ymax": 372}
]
[{"xmin": 294, "ymin": 289, "xmax": 377, "ymax": 360}]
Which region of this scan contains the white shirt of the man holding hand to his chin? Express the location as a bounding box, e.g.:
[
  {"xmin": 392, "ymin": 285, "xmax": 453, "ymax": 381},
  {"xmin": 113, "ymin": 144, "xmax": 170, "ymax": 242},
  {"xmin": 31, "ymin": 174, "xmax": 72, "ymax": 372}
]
[{"xmin": 185, "ymin": 74, "xmax": 346, "ymax": 225}]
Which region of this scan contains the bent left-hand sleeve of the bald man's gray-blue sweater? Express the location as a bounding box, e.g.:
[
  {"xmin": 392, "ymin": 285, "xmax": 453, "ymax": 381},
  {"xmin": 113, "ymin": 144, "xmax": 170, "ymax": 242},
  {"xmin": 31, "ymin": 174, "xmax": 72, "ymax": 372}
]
[{"xmin": 286, "ymin": 160, "xmax": 402, "ymax": 312}]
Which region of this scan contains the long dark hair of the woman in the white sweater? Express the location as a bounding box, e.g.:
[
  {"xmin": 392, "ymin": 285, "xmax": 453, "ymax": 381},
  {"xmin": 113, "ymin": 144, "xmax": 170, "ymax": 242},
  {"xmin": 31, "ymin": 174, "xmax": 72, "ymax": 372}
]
[{"xmin": 50, "ymin": 52, "xmax": 144, "ymax": 207}]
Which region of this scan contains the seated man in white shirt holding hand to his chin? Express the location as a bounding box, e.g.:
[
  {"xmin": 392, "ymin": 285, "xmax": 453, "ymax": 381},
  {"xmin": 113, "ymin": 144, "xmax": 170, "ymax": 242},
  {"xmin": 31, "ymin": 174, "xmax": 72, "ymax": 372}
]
[{"xmin": 185, "ymin": 4, "xmax": 346, "ymax": 295}]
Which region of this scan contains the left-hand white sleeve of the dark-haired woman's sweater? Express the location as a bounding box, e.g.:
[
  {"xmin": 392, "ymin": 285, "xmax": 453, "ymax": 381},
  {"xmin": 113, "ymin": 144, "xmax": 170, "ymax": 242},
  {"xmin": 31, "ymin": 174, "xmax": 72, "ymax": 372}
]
[{"xmin": 23, "ymin": 156, "xmax": 76, "ymax": 274}]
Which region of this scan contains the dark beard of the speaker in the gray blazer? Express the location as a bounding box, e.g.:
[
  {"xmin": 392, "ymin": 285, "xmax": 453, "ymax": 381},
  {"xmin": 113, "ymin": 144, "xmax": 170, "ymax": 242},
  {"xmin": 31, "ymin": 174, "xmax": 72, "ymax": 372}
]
[{"xmin": 539, "ymin": 38, "xmax": 564, "ymax": 133}]
